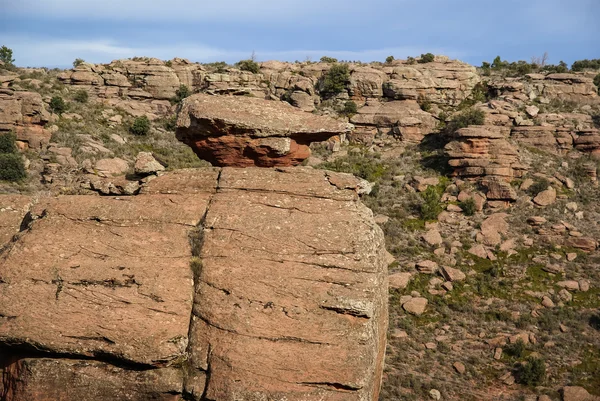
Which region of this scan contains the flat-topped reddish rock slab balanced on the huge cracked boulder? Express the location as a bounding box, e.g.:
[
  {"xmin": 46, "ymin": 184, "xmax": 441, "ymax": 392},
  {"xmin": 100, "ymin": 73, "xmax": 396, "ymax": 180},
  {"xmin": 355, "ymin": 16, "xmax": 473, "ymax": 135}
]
[{"xmin": 177, "ymin": 94, "xmax": 351, "ymax": 167}]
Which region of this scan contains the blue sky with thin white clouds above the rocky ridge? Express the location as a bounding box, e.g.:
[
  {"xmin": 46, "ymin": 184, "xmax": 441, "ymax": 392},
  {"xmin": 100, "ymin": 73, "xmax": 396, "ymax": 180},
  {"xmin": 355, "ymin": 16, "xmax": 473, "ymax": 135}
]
[{"xmin": 0, "ymin": 0, "xmax": 600, "ymax": 67}]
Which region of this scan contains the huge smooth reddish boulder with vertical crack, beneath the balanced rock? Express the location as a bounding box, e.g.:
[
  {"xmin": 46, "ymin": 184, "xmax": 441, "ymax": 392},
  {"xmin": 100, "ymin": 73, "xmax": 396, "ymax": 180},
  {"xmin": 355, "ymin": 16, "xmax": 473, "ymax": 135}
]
[{"xmin": 0, "ymin": 168, "xmax": 387, "ymax": 401}]
